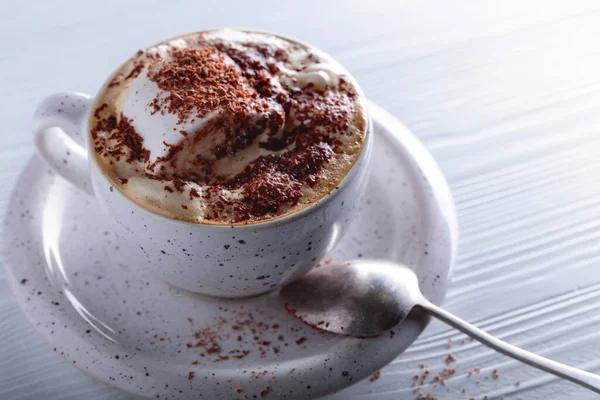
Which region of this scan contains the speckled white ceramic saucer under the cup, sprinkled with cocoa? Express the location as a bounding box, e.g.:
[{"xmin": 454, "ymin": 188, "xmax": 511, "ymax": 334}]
[{"xmin": 2, "ymin": 104, "xmax": 457, "ymax": 399}]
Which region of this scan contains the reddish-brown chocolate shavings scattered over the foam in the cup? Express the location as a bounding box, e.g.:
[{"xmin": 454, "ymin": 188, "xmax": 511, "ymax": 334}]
[{"xmin": 91, "ymin": 35, "xmax": 357, "ymax": 223}]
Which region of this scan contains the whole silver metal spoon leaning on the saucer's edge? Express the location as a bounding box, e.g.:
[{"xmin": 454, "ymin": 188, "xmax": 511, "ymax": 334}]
[{"xmin": 281, "ymin": 260, "xmax": 600, "ymax": 393}]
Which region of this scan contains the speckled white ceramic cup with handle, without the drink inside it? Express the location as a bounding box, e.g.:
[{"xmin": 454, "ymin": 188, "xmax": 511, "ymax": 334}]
[{"xmin": 34, "ymin": 32, "xmax": 373, "ymax": 297}]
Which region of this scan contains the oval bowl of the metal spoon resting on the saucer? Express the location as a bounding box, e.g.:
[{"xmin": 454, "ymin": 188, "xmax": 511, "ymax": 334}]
[{"xmin": 281, "ymin": 261, "xmax": 422, "ymax": 337}]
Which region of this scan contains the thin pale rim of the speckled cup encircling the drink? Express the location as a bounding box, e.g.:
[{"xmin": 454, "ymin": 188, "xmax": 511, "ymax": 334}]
[{"xmin": 85, "ymin": 27, "xmax": 373, "ymax": 230}]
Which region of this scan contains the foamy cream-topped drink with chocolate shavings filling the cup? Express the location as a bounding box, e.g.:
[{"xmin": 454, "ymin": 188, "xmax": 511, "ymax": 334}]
[{"xmin": 89, "ymin": 30, "xmax": 367, "ymax": 224}]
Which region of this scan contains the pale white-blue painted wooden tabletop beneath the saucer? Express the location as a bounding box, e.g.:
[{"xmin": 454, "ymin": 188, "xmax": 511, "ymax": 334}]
[{"xmin": 0, "ymin": 0, "xmax": 600, "ymax": 400}]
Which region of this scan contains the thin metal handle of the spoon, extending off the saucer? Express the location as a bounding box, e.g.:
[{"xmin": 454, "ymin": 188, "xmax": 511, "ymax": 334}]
[{"xmin": 418, "ymin": 300, "xmax": 600, "ymax": 393}]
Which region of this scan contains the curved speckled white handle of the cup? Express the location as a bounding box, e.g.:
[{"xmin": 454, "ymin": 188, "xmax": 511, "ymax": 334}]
[{"xmin": 33, "ymin": 92, "xmax": 93, "ymax": 195}]
